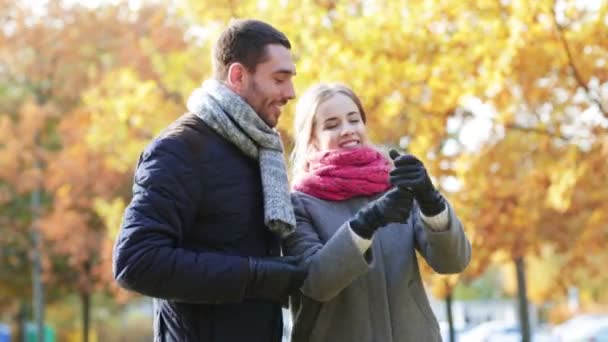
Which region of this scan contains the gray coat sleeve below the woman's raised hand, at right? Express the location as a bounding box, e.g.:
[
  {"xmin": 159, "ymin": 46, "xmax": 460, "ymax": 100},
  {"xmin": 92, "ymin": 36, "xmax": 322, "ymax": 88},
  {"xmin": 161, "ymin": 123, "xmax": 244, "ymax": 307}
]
[{"xmin": 412, "ymin": 200, "xmax": 471, "ymax": 274}]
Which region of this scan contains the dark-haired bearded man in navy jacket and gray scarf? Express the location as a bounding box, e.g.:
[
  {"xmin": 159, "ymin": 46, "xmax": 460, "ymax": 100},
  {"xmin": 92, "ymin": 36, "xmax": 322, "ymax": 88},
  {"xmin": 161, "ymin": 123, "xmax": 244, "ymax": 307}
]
[{"xmin": 113, "ymin": 20, "xmax": 307, "ymax": 342}]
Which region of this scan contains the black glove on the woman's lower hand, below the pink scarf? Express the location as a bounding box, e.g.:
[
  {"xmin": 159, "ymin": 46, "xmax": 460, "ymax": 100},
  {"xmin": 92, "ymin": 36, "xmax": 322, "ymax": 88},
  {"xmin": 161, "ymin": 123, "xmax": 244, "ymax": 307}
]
[{"xmin": 349, "ymin": 188, "xmax": 414, "ymax": 239}]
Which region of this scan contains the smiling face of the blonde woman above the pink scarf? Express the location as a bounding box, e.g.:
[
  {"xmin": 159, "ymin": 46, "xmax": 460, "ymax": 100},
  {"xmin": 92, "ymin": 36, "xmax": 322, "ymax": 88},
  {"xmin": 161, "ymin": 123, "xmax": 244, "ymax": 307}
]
[{"xmin": 311, "ymin": 93, "xmax": 368, "ymax": 151}]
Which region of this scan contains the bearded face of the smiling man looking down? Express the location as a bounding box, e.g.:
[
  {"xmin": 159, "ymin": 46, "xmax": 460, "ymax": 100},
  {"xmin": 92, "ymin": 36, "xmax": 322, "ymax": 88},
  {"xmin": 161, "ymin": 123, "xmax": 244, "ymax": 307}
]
[{"xmin": 239, "ymin": 44, "xmax": 296, "ymax": 127}]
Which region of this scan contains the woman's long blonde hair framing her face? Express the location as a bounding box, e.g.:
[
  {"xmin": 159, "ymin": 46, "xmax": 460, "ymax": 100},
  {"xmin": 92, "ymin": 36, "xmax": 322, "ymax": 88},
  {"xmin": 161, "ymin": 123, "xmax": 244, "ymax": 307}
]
[{"xmin": 291, "ymin": 83, "xmax": 366, "ymax": 182}]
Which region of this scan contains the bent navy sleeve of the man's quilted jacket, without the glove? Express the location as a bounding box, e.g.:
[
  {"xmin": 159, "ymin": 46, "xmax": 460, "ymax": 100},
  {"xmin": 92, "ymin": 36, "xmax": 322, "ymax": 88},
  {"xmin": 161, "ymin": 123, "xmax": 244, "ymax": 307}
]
[{"xmin": 112, "ymin": 138, "xmax": 249, "ymax": 303}]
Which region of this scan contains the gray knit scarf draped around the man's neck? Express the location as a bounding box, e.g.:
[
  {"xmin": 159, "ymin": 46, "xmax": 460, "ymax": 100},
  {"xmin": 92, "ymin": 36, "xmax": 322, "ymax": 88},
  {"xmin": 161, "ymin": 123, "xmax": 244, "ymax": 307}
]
[{"xmin": 187, "ymin": 80, "xmax": 296, "ymax": 237}]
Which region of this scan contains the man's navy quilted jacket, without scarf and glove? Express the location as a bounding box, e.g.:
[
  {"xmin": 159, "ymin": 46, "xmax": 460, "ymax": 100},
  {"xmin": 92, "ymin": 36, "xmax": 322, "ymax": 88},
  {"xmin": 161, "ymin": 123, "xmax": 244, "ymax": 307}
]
[{"xmin": 113, "ymin": 114, "xmax": 282, "ymax": 342}]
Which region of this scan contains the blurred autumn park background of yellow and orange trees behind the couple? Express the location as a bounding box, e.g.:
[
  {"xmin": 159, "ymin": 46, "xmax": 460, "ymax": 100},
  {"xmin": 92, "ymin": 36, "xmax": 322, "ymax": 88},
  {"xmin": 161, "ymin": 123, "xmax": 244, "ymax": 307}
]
[{"xmin": 0, "ymin": 0, "xmax": 608, "ymax": 341}]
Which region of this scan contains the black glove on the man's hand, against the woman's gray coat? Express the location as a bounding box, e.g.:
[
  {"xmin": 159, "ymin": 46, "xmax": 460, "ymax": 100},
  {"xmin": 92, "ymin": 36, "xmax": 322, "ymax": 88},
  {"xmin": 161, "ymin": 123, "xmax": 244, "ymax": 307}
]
[{"xmin": 245, "ymin": 256, "xmax": 309, "ymax": 303}]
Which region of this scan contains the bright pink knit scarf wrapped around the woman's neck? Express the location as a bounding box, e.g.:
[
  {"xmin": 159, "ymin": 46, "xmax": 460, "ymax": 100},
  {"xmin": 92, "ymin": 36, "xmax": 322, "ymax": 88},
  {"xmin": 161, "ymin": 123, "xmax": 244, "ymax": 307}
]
[{"xmin": 294, "ymin": 147, "xmax": 391, "ymax": 201}]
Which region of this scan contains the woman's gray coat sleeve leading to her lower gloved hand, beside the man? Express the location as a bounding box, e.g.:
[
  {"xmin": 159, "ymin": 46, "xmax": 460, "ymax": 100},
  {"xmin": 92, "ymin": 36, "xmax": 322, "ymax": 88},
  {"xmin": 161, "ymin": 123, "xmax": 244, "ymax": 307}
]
[{"xmin": 283, "ymin": 194, "xmax": 372, "ymax": 302}]
